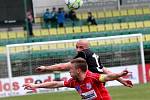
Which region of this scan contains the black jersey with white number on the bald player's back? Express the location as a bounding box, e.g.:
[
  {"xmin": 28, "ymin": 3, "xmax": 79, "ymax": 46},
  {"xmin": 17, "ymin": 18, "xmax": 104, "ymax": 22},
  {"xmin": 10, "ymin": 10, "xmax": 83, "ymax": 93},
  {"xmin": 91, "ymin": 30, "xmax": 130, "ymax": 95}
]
[{"xmin": 74, "ymin": 49, "xmax": 103, "ymax": 73}]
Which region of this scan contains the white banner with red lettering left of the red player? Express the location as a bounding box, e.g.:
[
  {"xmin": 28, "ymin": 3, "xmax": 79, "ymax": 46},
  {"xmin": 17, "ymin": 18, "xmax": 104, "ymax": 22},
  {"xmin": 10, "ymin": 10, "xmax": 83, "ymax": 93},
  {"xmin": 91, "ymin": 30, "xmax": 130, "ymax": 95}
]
[{"xmin": 0, "ymin": 72, "xmax": 72, "ymax": 97}]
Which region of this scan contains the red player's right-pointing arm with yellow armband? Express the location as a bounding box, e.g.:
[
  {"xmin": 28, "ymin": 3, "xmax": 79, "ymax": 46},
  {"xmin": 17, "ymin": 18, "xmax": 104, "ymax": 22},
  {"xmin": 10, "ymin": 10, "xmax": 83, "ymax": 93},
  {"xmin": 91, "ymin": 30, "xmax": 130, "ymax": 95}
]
[{"xmin": 100, "ymin": 70, "xmax": 128, "ymax": 82}]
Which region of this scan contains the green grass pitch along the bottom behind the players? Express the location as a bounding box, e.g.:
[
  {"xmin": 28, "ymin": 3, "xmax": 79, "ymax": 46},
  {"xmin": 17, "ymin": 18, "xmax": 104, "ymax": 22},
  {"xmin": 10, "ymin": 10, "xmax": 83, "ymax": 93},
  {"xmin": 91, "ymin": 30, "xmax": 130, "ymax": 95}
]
[{"xmin": 0, "ymin": 83, "xmax": 150, "ymax": 100}]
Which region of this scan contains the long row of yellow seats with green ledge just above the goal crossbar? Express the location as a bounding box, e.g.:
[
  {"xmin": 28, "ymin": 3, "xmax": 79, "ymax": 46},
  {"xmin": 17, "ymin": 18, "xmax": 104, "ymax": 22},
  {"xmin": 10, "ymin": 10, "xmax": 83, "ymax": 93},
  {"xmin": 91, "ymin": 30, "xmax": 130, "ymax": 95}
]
[{"xmin": 0, "ymin": 21, "xmax": 150, "ymax": 45}]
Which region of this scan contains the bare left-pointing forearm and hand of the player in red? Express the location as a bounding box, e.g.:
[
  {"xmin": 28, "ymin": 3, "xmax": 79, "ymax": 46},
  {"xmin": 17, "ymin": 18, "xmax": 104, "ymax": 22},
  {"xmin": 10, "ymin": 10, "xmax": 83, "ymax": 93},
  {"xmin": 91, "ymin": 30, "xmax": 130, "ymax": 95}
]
[{"xmin": 23, "ymin": 81, "xmax": 64, "ymax": 90}]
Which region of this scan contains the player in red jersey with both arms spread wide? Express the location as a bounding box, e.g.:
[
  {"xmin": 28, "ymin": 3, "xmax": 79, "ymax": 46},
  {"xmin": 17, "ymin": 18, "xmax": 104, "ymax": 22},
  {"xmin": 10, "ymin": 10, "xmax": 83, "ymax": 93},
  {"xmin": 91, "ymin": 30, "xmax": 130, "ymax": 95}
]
[{"xmin": 23, "ymin": 58, "xmax": 128, "ymax": 100}]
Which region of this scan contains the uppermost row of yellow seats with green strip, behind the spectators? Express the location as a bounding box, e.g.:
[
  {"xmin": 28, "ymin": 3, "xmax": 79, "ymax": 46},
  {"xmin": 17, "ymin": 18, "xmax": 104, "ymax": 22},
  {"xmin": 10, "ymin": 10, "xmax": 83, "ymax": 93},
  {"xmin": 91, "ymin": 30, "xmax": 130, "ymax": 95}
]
[{"xmin": 35, "ymin": 8, "xmax": 150, "ymax": 26}]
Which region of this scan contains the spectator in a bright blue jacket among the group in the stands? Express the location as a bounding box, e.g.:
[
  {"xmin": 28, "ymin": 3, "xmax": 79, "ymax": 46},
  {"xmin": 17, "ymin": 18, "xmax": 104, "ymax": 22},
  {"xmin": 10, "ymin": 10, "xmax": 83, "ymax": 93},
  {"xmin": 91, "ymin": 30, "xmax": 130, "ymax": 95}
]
[{"xmin": 57, "ymin": 8, "xmax": 65, "ymax": 27}]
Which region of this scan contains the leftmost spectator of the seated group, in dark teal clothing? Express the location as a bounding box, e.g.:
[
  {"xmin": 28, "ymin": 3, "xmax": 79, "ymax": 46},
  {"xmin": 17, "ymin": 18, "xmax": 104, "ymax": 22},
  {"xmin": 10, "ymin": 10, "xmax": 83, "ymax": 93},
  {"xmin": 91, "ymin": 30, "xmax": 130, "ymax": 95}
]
[{"xmin": 51, "ymin": 7, "xmax": 57, "ymax": 28}]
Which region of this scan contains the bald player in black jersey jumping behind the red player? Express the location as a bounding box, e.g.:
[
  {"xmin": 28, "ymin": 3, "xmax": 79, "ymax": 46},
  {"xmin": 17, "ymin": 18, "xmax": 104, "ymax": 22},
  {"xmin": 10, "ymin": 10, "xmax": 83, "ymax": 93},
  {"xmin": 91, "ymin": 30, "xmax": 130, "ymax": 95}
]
[{"xmin": 36, "ymin": 40, "xmax": 133, "ymax": 87}]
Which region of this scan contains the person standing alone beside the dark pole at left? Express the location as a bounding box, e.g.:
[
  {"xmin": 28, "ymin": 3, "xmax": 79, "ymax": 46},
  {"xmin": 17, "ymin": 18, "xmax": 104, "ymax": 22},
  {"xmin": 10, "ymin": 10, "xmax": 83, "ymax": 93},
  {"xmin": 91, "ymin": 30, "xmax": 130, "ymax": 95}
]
[{"xmin": 26, "ymin": 10, "xmax": 33, "ymax": 36}]
